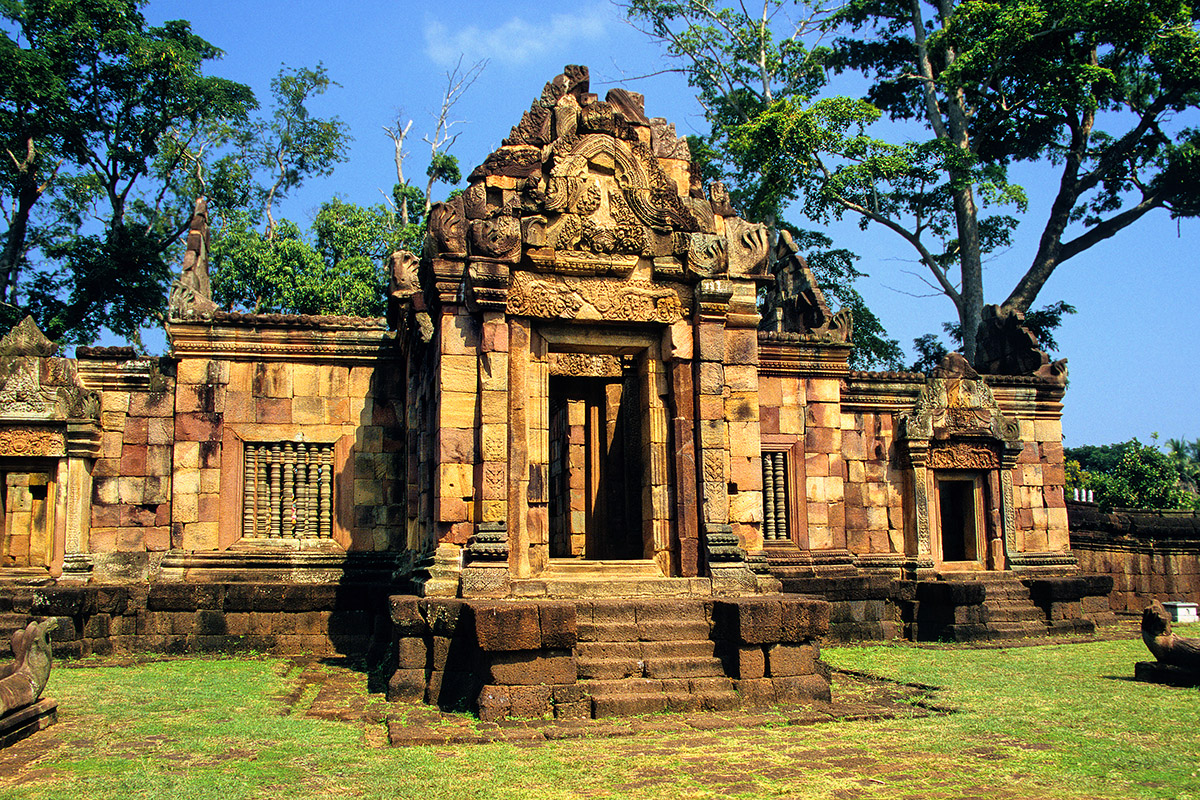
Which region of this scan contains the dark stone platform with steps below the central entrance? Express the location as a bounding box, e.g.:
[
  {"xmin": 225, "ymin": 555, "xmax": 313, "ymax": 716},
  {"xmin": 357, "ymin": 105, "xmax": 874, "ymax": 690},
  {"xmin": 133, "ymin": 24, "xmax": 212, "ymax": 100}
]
[{"xmin": 388, "ymin": 595, "xmax": 829, "ymax": 721}]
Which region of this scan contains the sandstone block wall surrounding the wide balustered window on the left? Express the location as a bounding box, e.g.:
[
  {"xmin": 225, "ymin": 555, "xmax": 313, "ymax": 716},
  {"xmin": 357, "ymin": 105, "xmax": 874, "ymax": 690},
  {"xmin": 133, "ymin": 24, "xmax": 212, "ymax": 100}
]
[{"xmin": 170, "ymin": 345, "xmax": 404, "ymax": 551}]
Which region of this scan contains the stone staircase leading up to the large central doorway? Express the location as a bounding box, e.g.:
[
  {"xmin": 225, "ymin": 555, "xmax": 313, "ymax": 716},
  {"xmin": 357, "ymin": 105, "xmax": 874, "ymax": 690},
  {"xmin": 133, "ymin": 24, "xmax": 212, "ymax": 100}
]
[{"xmin": 576, "ymin": 600, "xmax": 740, "ymax": 718}]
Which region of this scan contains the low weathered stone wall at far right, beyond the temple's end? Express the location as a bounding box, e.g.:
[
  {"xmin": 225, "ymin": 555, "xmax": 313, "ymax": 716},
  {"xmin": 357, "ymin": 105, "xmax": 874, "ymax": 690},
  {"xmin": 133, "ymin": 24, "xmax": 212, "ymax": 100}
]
[{"xmin": 1067, "ymin": 503, "xmax": 1200, "ymax": 613}]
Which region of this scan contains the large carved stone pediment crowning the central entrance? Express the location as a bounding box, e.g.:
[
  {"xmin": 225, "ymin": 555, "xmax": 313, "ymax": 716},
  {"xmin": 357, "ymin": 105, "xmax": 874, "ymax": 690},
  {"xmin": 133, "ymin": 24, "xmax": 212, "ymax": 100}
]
[{"xmin": 424, "ymin": 66, "xmax": 770, "ymax": 320}]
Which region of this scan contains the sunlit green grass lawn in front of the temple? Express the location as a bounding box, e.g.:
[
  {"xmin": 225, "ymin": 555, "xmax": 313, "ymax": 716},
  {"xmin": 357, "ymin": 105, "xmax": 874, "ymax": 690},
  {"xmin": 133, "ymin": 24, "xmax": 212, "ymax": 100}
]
[{"xmin": 0, "ymin": 626, "xmax": 1200, "ymax": 800}]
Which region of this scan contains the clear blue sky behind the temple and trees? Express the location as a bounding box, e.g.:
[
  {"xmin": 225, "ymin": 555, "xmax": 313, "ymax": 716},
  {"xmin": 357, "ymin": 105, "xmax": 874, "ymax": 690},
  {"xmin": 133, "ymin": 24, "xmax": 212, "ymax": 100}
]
[{"xmin": 145, "ymin": 0, "xmax": 1200, "ymax": 446}]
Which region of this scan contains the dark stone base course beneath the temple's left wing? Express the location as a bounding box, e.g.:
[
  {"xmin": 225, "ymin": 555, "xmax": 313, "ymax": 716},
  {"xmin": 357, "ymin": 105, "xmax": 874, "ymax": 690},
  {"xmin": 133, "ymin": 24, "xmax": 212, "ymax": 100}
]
[{"xmin": 0, "ymin": 583, "xmax": 395, "ymax": 658}]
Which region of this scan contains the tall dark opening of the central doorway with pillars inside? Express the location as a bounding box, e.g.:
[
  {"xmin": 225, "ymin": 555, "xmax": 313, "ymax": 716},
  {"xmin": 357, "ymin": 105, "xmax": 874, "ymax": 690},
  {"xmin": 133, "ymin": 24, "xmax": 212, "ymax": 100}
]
[{"xmin": 548, "ymin": 367, "xmax": 648, "ymax": 560}]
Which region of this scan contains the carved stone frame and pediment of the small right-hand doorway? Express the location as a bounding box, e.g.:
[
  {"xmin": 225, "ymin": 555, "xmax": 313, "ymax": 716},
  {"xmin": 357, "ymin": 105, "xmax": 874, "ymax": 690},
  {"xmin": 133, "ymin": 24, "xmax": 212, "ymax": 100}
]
[{"xmin": 896, "ymin": 367, "xmax": 1024, "ymax": 570}]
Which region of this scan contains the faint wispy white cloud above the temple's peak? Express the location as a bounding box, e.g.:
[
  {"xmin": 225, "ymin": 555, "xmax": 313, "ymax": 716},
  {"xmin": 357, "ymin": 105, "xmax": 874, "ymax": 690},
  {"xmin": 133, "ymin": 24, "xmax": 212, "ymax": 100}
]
[{"xmin": 425, "ymin": 6, "xmax": 608, "ymax": 67}]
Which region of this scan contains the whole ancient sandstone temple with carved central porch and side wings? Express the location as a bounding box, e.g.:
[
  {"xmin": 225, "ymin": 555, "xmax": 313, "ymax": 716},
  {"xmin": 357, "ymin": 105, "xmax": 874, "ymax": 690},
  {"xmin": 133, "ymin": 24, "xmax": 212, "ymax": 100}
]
[{"xmin": 0, "ymin": 66, "xmax": 1111, "ymax": 717}]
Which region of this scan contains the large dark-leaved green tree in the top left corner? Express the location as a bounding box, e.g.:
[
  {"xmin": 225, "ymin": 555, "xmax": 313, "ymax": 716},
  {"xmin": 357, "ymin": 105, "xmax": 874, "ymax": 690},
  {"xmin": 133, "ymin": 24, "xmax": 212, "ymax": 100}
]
[{"xmin": 0, "ymin": 0, "xmax": 254, "ymax": 342}]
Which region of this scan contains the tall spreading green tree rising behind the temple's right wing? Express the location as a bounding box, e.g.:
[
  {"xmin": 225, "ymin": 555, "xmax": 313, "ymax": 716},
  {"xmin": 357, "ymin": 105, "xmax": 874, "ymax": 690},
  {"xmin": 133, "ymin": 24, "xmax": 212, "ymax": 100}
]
[{"xmin": 628, "ymin": 0, "xmax": 1200, "ymax": 359}]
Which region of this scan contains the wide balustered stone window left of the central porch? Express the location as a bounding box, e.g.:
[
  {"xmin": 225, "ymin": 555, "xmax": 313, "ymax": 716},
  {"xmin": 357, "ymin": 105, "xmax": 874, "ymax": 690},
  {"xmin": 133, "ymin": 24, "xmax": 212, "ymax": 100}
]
[{"xmin": 242, "ymin": 441, "xmax": 334, "ymax": 539}]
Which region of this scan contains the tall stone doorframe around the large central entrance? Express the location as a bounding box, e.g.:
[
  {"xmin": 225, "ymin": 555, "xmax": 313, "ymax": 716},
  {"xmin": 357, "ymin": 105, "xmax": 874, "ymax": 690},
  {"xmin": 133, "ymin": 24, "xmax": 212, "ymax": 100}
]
[{"xmin": 509, "ymin": 323, "xmax": 678, "ymax": 578}]
